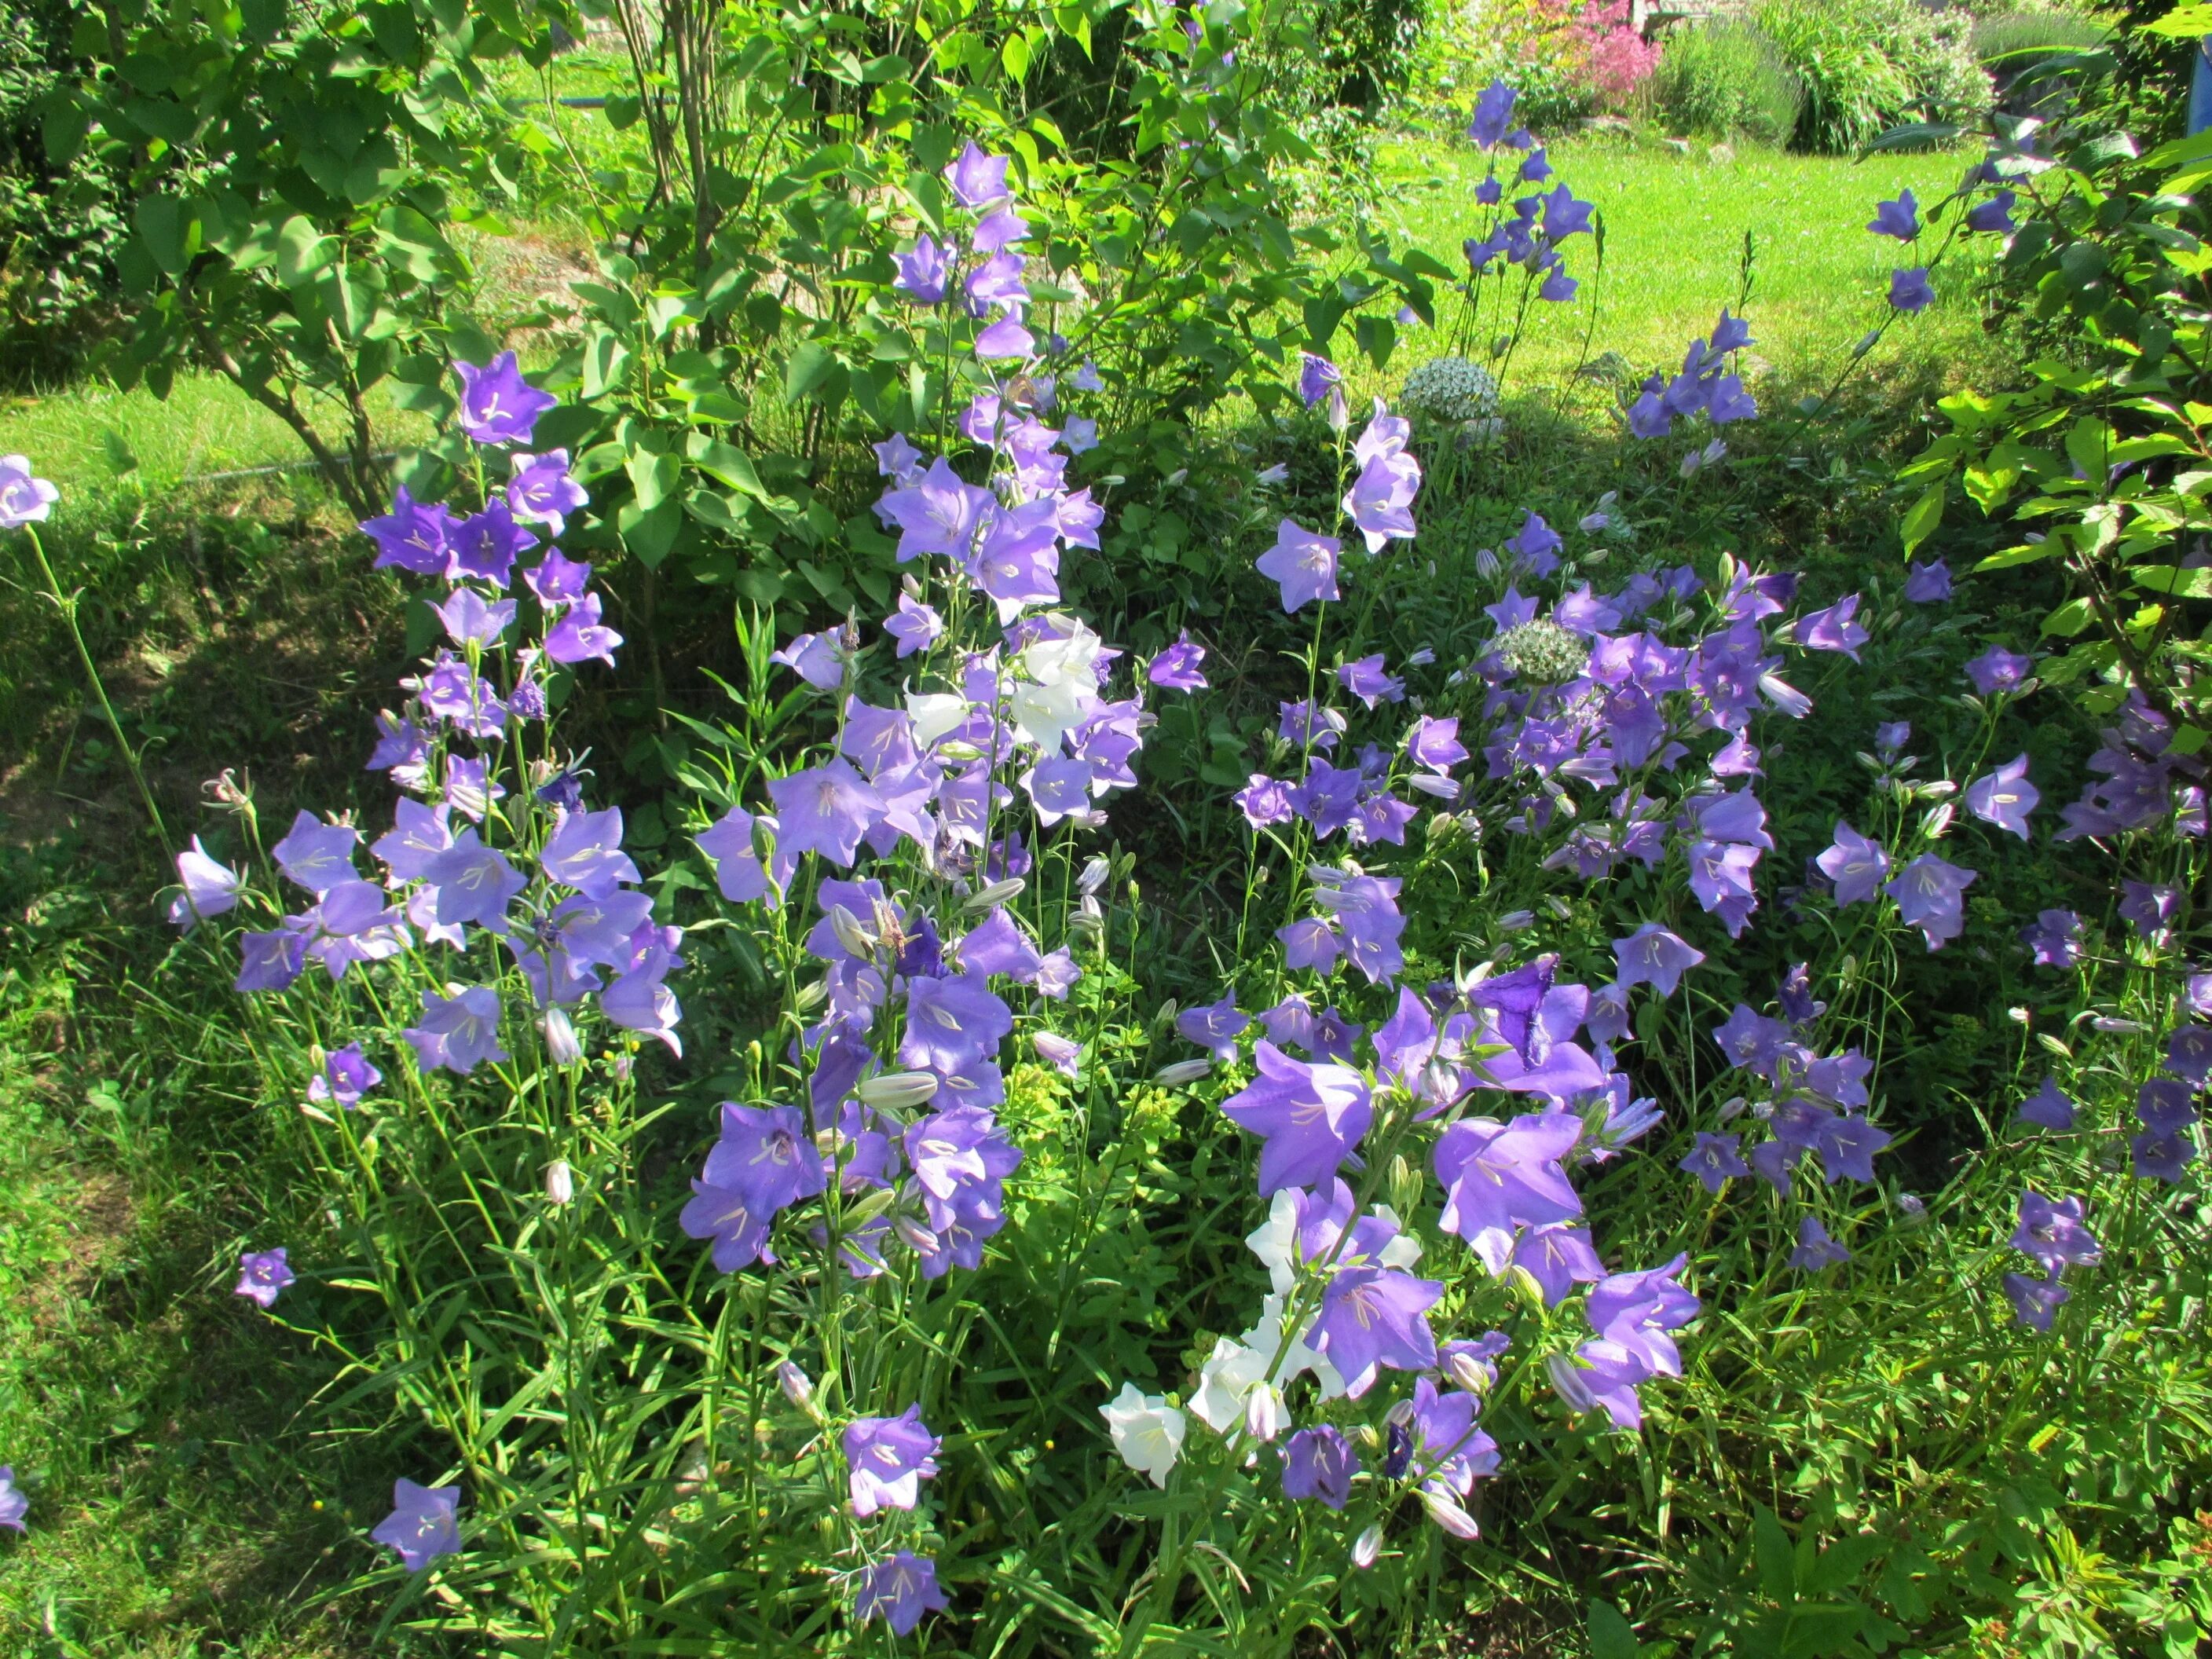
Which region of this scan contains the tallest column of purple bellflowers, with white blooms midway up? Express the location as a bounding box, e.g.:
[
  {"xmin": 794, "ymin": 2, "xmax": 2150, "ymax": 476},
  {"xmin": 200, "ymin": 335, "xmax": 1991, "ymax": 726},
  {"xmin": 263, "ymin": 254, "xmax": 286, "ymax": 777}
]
[{"xmin": 681, "ymin": 141, "xmax": 1206, "ymax": 1635}]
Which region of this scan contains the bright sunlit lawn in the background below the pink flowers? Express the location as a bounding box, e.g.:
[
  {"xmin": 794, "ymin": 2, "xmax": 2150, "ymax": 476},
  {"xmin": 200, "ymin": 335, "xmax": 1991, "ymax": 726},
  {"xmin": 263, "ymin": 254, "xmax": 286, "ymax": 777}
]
[{"xmin": 1376, "ymin": 139, "xmax": 1993, "ymax": 390}]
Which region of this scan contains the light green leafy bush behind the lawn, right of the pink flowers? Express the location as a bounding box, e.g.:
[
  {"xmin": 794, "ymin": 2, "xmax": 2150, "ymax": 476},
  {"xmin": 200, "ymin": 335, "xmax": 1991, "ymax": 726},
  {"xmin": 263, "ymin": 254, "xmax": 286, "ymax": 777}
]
[{"xmin": 1752, "ymin": 0, "xmax": 1990, "ymax": 150}]
